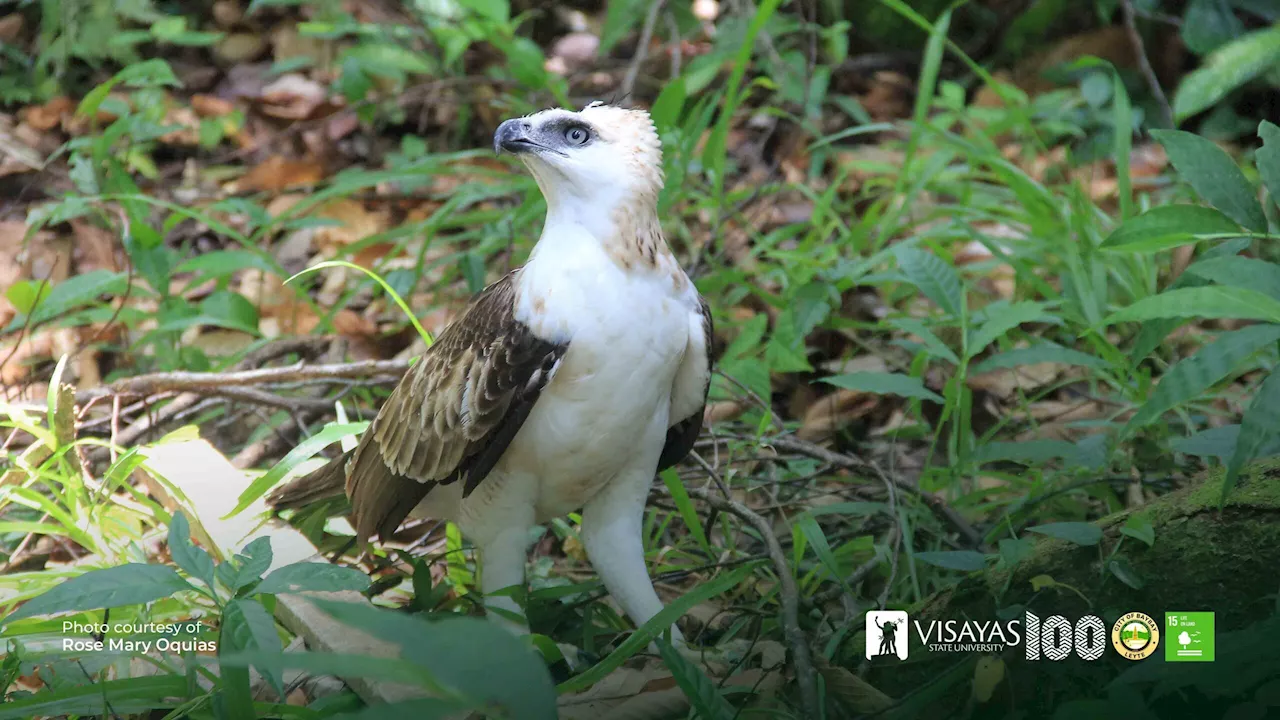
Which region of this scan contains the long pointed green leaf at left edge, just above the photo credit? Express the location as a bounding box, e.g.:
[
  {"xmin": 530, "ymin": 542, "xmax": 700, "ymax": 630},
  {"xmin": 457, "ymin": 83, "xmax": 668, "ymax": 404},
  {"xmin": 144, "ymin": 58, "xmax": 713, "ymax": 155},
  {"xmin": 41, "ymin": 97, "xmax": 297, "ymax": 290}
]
[{"xmin": 3, "ymin": 562, "xmax": 191, "ymax": 623}]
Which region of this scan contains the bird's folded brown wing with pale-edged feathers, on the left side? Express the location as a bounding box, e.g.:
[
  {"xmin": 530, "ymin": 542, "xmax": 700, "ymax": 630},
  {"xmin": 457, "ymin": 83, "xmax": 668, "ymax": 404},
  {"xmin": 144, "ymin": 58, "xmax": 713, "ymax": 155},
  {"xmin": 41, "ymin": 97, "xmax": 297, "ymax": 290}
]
[{"xmin": 347, "ymin": 273, "xmax": 568, "ymax": 541}]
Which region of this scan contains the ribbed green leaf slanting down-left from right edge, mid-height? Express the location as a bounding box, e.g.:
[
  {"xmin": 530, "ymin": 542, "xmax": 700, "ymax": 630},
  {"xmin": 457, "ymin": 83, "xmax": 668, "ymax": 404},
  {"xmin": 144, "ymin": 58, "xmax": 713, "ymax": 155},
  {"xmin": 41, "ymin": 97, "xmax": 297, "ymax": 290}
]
[{"xmin": 1120, "ymin": 325, "xmax": 1280, "ymax": 437}]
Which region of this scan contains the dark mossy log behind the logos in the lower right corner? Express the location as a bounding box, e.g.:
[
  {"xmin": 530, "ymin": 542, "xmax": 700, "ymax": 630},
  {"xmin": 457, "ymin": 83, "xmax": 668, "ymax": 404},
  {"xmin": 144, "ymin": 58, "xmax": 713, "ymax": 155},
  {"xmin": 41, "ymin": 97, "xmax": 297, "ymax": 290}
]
[{"xmin": 844, "ymin": 460, "xmax": 1280, "ymax": 719}]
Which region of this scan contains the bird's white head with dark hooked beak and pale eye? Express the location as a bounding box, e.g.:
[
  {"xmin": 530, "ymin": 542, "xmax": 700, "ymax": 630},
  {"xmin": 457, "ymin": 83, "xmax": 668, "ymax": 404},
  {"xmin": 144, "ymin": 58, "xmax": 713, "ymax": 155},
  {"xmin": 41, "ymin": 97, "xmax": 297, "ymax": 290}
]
[{"xmin": 493, "ymin": 102, "xmax": 663, "ymax": 213}]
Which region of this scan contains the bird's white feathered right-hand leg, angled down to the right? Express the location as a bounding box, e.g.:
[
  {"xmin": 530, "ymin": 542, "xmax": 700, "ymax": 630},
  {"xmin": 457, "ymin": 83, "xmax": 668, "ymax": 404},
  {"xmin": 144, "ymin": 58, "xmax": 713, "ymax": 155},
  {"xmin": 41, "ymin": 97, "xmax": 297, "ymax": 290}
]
[{"xmin": 581, "ymin": 466, "xmax": 684, "ymax": 644}]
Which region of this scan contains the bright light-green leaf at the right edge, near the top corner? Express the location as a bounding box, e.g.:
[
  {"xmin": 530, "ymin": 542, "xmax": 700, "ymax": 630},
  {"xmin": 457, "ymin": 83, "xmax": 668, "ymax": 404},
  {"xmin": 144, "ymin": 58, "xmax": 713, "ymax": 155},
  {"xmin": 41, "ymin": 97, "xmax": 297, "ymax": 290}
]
[{"xmin": 1174, "ymin": 27, "xmax": 1280, "ymax": 122}]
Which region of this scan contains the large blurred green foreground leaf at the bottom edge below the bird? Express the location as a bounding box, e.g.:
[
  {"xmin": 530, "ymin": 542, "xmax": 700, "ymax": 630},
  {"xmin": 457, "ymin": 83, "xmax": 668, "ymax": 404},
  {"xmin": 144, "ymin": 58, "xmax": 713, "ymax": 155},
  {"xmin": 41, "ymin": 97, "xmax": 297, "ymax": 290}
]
[{"xmin": 312, "ymin": 597, "xmax": 557, "ymax": 720}]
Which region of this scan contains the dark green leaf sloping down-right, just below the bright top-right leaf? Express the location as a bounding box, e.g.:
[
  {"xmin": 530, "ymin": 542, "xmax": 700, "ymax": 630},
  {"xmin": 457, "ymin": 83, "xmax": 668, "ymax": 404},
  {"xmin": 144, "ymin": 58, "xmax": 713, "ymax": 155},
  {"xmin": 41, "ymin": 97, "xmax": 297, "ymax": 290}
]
[{"xmin": 1151, "ymin": 127, "xmax": 1280, "ymax": 232}]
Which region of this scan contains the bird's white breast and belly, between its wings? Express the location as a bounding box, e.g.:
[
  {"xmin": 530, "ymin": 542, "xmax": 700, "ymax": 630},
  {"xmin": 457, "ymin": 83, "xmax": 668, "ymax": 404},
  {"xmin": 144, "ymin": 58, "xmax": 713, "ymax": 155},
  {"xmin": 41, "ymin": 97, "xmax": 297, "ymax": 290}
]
[{"xmin": 502, "ymin": 222, "xmax": 696, "ymax": 519}]
